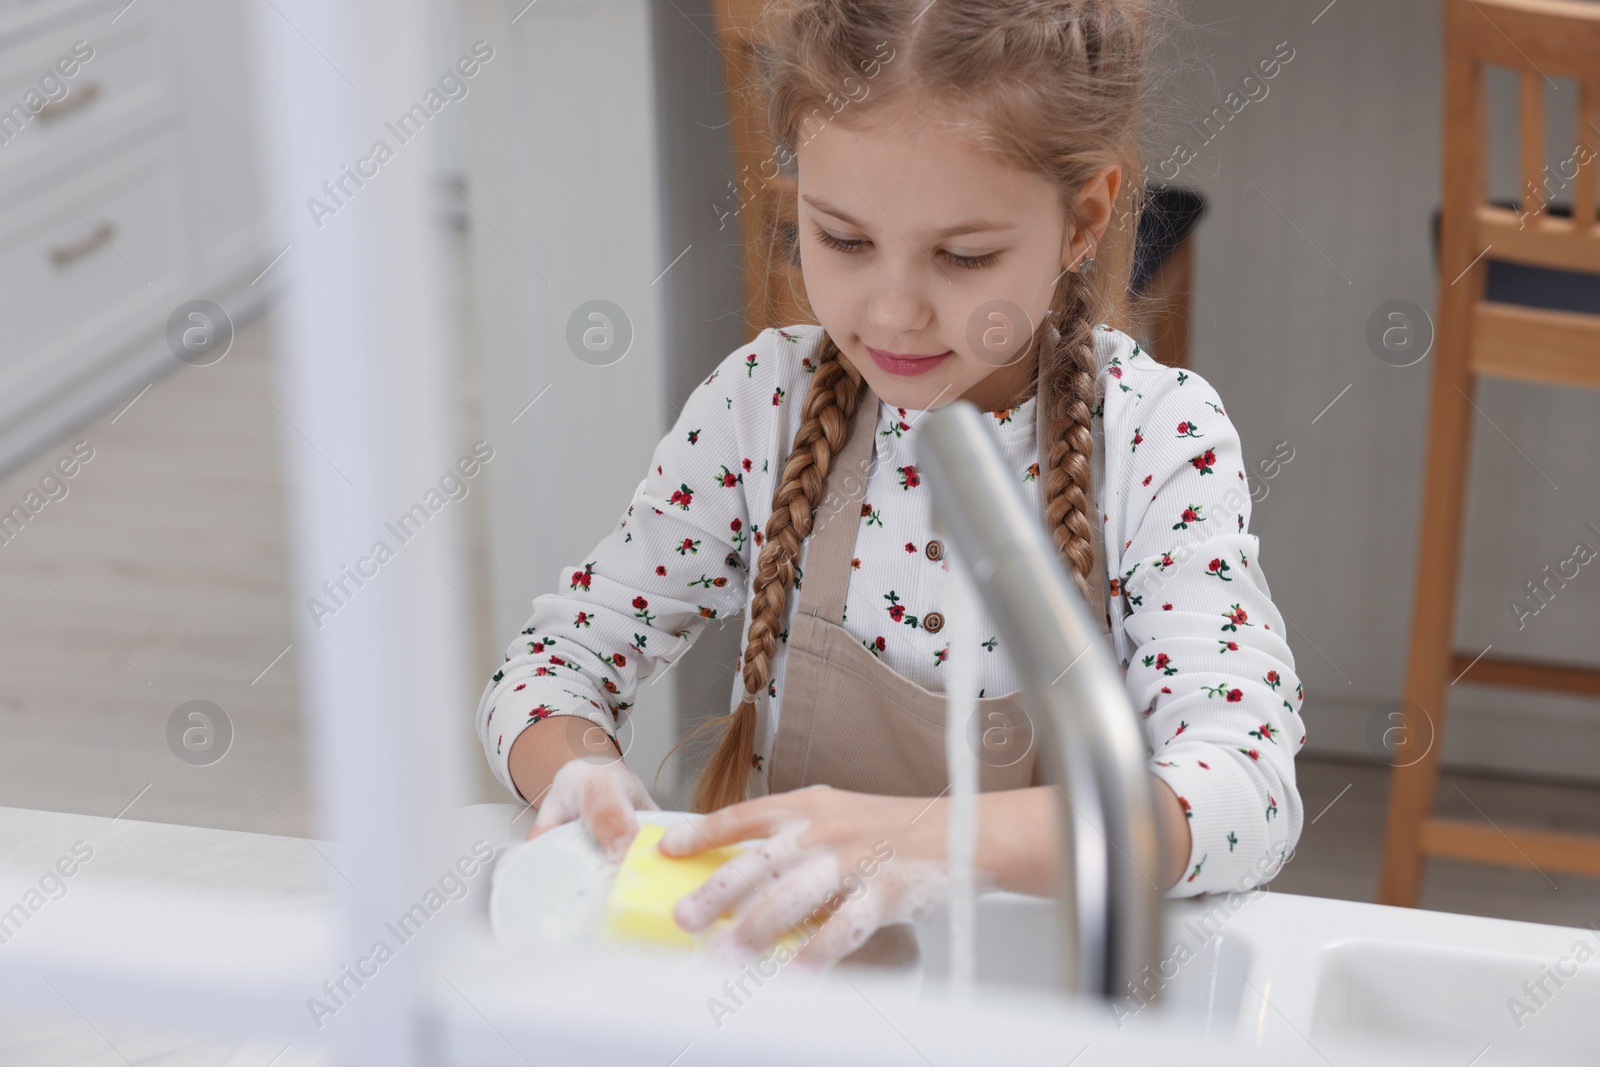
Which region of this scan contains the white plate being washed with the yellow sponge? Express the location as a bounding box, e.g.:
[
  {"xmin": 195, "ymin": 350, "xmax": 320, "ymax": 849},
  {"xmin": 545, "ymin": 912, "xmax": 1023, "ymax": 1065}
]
[{"xmin": 490, "ymin": 811, "xmax": 706, "ymax": 944}]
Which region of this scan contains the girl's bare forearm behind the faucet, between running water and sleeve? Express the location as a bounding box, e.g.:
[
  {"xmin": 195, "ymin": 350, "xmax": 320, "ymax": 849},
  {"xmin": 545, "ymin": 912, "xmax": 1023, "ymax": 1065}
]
[{"xmin": 960, "ymin": 779, "xmax": 1190, "ymax": 896}]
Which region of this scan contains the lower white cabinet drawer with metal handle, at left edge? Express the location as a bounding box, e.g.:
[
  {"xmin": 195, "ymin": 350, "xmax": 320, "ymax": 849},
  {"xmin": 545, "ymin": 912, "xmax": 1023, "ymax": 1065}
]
[{"xmin": 0, "ymin": 125, "xmax": 184, "ymax": 409}]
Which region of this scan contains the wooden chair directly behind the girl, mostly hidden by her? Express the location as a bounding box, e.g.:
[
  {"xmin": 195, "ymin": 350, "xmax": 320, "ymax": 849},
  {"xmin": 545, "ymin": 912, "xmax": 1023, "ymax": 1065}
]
[{"xmin": 712, "ymin": 0, "xmax": 1205, "ymax": 366}]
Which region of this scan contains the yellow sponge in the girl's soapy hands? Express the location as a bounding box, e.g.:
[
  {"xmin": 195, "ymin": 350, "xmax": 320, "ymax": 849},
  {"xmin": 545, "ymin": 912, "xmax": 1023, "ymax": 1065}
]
[{"xmin": 605, "ymin": 822, "xmax": 827, "ymax": 950}]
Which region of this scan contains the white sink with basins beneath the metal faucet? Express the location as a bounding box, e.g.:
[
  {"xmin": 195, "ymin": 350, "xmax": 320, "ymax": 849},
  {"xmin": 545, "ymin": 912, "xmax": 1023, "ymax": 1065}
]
[{"xmin": 917, "ymin": 891, "xmax": 1600, "ymax": 1067}]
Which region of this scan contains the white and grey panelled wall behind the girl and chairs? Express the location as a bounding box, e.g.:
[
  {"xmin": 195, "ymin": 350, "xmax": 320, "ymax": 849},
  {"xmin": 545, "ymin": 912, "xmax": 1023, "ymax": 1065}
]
[{"xmin": 466, "ymin": 0, "xmax": 1600, "ymax": 793}]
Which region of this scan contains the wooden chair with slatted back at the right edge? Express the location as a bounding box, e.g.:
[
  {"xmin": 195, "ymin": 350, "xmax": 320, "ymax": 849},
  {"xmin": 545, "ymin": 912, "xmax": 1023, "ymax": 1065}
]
[{"xmin": 1378, "ymin": 0, "xmax": 1600, "ymax": 905}]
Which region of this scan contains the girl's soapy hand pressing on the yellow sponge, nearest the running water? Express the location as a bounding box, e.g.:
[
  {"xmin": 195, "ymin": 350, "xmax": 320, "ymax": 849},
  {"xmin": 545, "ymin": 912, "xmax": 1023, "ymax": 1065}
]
[{"xmin": 659, "ymin": 785, "xmax": 949, "ymax": 971}]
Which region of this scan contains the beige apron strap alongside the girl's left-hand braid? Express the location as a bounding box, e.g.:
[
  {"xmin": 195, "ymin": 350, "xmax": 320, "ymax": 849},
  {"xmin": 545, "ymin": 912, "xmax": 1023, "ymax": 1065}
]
[{"xmin": 795, "ymin": 379, "xmax": 880, "ymax": 624}]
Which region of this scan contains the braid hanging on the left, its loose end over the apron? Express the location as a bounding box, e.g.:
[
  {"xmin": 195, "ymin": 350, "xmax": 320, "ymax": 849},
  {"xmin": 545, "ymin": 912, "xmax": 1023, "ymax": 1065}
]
[{"xmin": 667, "ymin": 334, "xmax": 866, "ymax": 813}]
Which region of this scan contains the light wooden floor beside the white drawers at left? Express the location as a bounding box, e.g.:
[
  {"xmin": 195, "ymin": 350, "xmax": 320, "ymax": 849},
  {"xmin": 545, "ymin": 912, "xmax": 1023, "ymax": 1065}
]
[{"xmin": 0, "ymin": 232, "xmax": 509, "ymax": 835}]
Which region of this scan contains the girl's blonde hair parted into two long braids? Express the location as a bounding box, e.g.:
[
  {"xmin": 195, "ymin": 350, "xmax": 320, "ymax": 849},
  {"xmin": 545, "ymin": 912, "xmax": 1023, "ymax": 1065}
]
[{"xmin": 667, "ymin": 0, "xmax": 1149, "ymax": 813}]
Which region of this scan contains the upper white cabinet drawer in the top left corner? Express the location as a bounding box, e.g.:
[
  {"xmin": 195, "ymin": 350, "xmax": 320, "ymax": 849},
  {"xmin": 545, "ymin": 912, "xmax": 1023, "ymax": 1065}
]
[{"xmin": 0, "ymin": 0, "xmax": 174, "ymax": 187}]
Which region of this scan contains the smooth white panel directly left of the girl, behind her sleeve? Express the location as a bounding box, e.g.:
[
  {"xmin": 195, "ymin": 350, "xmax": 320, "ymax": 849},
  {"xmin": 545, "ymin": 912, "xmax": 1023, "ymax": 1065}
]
[{"xmin": 462, "ymin": 0, "xmax": 680, "ymax": 799}]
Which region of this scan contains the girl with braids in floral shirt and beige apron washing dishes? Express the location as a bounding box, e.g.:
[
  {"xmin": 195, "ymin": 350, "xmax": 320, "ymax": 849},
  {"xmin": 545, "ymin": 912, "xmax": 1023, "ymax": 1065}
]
[{"xmin": 478, "ymin": 0, "xmax": 1306, "ymax": 968}]
